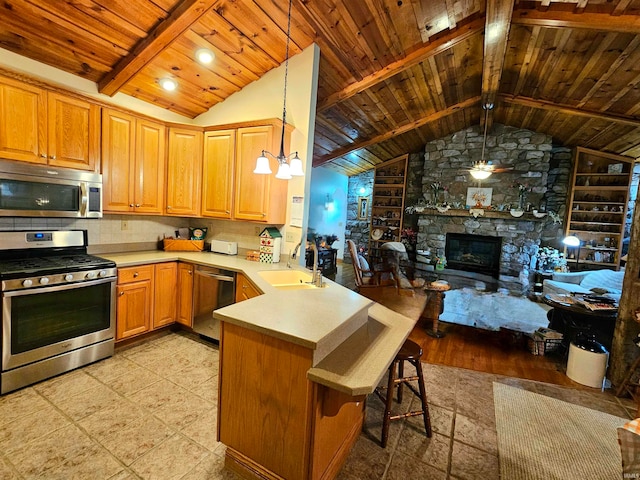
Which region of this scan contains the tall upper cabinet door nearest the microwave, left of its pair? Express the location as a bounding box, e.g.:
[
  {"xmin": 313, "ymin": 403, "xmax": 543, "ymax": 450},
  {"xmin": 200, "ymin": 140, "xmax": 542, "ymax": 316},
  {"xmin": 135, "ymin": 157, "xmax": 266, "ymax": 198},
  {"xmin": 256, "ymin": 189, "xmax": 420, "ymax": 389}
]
[{"xmin": 102, "ymin": 109, "xmax": 135, "ymax": 212}]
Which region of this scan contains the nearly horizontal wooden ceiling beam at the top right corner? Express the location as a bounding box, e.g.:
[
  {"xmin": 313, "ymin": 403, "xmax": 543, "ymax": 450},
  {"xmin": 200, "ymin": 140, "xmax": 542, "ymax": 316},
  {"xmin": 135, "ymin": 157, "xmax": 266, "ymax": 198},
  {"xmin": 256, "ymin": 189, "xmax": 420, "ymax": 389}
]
[{"xmin": 511, "ymin": 8, "xmax": 640, "ymax": 34}]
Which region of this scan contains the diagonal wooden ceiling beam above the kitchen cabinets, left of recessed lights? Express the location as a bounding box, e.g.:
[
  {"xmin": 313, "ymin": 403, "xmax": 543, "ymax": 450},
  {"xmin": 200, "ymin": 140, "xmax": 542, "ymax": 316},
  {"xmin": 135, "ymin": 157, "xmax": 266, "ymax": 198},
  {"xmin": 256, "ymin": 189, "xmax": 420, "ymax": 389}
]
[{"xmin": 98, "ymin": 0, "xmax": 216, "ymax": 96}]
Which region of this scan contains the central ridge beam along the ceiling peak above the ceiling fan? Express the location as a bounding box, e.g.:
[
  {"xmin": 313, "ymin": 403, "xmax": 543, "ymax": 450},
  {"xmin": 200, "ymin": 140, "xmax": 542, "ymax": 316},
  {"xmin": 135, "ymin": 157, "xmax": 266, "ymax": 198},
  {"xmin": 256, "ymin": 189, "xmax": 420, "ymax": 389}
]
[{"xmin": 481, "ymin": 0, "xmax": 514, "ymax": 128}]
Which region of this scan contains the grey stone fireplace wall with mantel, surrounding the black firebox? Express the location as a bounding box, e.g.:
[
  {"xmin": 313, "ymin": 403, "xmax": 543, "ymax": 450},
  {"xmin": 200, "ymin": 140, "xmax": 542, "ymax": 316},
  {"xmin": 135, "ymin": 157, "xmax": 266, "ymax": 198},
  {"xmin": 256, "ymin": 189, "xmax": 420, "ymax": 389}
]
[{"xmin": 404, "ymin": 124, "xmax": 571, "ymax": 278}]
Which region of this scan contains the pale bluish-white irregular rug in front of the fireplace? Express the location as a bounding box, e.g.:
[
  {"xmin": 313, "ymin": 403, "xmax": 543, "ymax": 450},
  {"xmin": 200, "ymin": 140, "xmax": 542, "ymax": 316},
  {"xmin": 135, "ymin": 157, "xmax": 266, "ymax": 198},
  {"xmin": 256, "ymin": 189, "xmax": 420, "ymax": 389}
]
[{"xmin": 440, "ymin": 288, "xmax": 550, "ymax": 333}]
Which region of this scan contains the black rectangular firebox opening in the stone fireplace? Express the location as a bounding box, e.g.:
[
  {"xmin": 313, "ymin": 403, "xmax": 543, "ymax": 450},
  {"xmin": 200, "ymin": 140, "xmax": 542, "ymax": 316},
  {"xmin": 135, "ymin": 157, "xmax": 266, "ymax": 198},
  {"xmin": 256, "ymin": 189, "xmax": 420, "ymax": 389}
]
[{"xmin": 445, "ymin": 233, "xmax": 502, "ymax": 278}]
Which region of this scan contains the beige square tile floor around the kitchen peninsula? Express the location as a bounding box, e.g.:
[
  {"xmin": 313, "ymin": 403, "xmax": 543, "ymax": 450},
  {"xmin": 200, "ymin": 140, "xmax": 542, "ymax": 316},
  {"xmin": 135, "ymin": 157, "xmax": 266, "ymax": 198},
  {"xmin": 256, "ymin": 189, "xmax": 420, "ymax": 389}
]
[{"xmin": 0, "ymin": 333, "xmax": 635, "ymax": 480}]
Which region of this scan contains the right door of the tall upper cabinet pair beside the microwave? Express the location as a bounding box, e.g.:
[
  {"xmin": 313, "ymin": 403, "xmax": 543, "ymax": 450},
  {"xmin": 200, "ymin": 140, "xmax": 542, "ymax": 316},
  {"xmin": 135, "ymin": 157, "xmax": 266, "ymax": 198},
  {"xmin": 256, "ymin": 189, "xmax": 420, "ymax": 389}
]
[{"xmin": 133, "ymin": 119, "xmax": 167, "ymax": 214}]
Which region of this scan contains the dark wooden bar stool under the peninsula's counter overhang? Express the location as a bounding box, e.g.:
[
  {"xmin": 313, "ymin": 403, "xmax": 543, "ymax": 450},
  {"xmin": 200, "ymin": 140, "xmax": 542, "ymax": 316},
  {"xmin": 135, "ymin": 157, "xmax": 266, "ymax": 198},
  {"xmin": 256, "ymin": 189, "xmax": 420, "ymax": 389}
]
[{"xmin": 375, "ymin": 339, "xmax": 432, "ymax": 448}]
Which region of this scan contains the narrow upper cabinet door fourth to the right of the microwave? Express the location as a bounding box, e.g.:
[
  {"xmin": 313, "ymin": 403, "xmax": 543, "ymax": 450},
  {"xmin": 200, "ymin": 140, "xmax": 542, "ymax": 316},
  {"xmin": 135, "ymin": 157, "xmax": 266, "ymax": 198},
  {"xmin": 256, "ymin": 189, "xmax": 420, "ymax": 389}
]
[{"xmin": 202, "ymin": 130, "xmax": 236, "ymax": 218}]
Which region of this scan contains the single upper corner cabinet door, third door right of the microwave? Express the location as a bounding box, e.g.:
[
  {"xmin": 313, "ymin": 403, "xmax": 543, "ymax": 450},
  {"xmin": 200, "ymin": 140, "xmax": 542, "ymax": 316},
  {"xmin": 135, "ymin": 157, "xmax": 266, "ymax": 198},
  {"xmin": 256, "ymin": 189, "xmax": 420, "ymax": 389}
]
[{"xmin": 166, "ymin": 127, "xmax": 203, "ymax": 217}]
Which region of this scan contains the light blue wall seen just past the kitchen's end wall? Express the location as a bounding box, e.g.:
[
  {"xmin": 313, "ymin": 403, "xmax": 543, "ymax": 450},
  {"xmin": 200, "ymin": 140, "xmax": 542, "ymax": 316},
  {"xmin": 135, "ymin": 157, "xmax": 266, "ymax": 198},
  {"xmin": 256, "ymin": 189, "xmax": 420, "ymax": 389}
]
[{"xmin": 309, "ymin": 167, "xmax": 349, "ymax": 258}]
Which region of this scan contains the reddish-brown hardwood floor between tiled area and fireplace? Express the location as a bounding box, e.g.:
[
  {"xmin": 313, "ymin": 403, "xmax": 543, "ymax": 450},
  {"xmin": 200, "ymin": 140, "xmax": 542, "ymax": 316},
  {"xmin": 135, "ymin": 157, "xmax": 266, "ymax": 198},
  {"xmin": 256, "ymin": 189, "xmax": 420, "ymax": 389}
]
[{"xmin": 334, "ymin": 263, "xmax": 580, "ymax": 390}]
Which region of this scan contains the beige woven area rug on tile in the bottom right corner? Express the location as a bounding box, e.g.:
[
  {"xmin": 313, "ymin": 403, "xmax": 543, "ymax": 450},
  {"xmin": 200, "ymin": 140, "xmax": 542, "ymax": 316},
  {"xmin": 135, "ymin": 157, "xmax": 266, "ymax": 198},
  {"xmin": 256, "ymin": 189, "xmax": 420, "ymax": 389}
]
[{"xmin": 493, "ymin": 382, "xmax": 628, "ymax": 480}]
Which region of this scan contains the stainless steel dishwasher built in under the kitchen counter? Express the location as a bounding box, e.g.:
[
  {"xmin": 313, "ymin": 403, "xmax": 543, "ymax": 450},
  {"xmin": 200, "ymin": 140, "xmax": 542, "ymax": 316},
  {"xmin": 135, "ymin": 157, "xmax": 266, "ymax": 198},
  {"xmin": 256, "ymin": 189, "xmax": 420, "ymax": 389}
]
[{"xmin": 193, "ymin": 265, "xmax": 236, "ymax": 340}]
